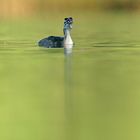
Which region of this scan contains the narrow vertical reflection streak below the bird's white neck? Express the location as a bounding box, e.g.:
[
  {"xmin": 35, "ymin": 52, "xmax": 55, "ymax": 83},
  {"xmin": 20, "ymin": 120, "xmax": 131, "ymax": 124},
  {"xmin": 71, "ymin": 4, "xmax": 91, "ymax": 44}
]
[{"xmin": 64, "ymin": 48, "xmax": 74, "ymax": 140}]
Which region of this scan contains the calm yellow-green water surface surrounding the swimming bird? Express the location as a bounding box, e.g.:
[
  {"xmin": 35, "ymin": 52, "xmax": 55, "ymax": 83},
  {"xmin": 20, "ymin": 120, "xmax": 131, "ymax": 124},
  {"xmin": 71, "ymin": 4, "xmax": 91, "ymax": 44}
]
[{"xmin": 0, "ymin": 13, "xmax": 140, "ymax": 140}]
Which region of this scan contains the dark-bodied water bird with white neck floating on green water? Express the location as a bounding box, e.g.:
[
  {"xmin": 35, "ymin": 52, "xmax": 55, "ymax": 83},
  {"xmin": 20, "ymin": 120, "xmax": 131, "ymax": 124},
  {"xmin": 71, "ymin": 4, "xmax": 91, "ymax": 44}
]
[{"xmin": 38, "ymin": 17, "xmax": 73, "ymax": 48}]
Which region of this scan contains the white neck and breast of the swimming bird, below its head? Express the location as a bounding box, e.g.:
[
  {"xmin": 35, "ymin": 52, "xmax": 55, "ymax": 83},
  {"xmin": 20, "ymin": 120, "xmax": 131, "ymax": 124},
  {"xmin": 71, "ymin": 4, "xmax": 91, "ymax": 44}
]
[{"xmin": 64, "ymin": 29, "xmax": 73, "ymax": 45}]
